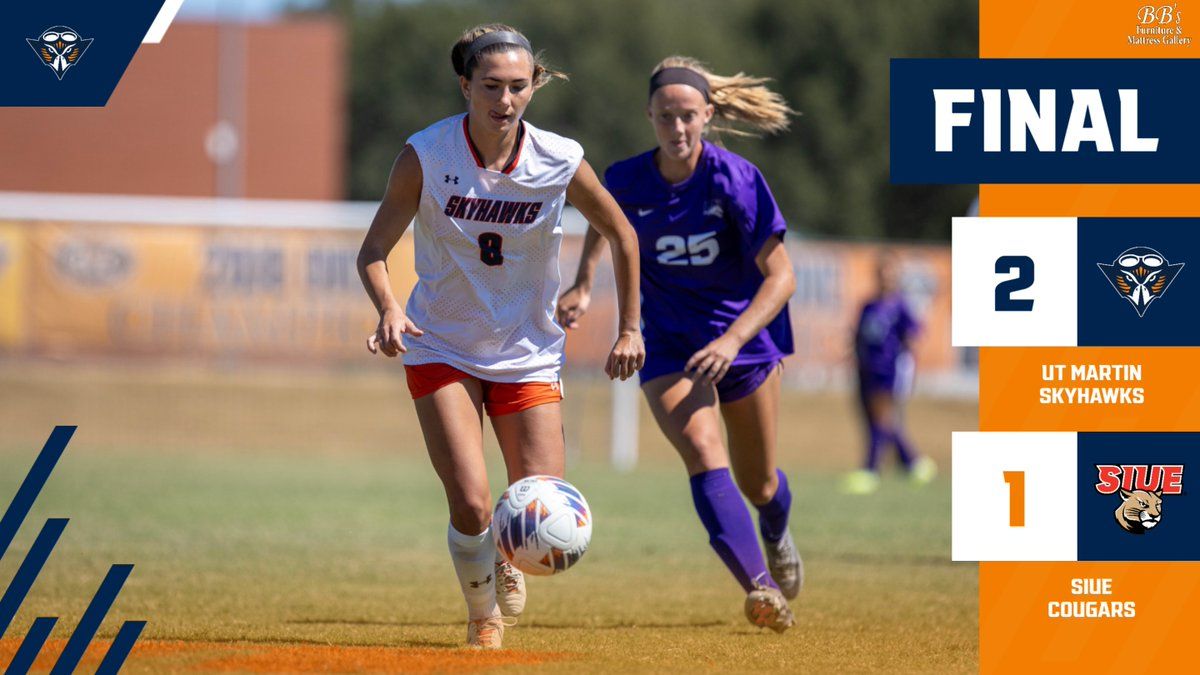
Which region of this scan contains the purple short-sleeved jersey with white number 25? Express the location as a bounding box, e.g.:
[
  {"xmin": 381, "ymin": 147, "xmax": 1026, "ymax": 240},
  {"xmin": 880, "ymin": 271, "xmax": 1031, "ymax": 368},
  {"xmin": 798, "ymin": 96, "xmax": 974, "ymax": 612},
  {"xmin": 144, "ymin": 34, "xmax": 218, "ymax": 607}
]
[{"xmin": 605, "ymin": 143, "xmax": 792, "ymax": 365}]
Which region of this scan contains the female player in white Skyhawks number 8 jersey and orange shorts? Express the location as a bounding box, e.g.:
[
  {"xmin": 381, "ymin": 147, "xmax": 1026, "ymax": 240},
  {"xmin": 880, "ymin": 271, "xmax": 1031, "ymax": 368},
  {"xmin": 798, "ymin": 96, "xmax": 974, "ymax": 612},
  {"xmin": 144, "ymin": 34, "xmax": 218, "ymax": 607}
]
[{"xmin": 358, "ymin": 24, "xmax": 644, "ymax": 649}]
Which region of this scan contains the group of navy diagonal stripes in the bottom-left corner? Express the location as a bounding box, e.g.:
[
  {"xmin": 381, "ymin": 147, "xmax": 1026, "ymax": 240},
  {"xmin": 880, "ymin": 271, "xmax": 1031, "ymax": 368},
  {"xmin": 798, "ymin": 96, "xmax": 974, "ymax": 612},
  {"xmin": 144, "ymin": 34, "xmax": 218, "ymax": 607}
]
[{"xmin": 0, "ymin": 426, "xmax": 146, "ymax": 675}]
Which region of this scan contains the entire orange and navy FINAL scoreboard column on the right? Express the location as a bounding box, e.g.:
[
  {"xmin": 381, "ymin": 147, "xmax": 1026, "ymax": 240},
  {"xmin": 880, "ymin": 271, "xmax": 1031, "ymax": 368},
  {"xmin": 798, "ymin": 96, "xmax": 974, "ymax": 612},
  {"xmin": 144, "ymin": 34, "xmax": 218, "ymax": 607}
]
[{"xmin": 890, "ymin": 0, "xmax": 1200, "ymax": 673}]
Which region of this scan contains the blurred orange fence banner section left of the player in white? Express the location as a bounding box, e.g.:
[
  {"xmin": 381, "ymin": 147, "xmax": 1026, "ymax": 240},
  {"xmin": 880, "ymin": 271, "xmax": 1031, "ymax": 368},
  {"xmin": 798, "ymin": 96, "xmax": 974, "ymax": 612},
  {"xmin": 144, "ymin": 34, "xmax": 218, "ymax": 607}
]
[{"xmin": 23, "ymin": 222, "xmax": 413, "ymax": 363}]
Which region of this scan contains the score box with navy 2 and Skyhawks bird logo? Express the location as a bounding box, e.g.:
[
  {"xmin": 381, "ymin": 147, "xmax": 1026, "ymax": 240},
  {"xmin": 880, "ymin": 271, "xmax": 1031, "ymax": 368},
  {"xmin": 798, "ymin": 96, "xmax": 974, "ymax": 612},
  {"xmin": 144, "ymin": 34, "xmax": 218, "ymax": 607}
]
[{"xmin": 952, "ymin": 217, "xmax": 1200, "ymax": 345}]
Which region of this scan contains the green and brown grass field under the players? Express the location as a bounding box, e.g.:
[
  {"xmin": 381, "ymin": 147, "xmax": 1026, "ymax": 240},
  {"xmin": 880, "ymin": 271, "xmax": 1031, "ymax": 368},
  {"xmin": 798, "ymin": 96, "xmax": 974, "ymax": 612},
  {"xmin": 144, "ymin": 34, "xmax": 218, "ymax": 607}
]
[{"xmin": 0, "ymin": 364, "xmax": 978, "ymax": 673}]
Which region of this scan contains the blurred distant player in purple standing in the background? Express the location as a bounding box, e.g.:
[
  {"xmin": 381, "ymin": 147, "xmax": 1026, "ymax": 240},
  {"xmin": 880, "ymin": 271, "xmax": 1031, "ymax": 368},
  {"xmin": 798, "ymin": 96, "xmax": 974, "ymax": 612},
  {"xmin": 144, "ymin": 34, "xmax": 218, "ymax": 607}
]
[{"xmin": 842, "ymin": 252, "xmax": 937, "ymax": 495}]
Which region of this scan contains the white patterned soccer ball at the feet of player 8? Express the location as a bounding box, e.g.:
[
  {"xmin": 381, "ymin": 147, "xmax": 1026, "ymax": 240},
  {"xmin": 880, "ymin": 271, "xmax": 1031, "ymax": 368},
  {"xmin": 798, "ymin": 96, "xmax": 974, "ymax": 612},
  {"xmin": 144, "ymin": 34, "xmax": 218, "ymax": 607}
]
[{"xmin": 492, "ymin": 476, "xmax": 592, "ymax": 577}]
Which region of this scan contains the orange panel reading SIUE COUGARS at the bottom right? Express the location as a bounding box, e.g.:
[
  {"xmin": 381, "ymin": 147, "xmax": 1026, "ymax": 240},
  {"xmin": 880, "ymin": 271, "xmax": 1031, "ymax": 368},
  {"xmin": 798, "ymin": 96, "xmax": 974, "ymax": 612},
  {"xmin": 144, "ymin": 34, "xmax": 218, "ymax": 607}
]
[{"xmin": 979, "ymin": 562, "xmax": 1200, "ymax": 673}]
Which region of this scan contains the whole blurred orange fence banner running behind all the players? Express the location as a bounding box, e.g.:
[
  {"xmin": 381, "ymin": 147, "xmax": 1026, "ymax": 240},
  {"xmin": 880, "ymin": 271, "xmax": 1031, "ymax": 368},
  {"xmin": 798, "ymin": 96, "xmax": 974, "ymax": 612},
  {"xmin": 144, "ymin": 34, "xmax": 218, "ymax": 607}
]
[{"xmin": 0, "ymin": 221, "xmax": 962, "ymax": 379}]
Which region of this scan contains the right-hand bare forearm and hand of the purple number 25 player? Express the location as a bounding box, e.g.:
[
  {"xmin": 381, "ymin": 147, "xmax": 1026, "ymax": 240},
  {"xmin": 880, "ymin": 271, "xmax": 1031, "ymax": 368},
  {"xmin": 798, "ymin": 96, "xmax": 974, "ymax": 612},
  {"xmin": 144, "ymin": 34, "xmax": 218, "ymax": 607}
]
[{"xmin": 684, "ymin": 237, "xmax": 796, "ymax": 382}]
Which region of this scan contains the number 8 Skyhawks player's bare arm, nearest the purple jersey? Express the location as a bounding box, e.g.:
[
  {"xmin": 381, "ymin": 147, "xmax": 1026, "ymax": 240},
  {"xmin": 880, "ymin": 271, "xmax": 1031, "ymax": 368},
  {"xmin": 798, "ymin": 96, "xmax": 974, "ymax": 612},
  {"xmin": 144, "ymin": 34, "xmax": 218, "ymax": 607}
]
[{"xmin": 566, "ymin": 161, "xmax": 646, "ymax": 380}]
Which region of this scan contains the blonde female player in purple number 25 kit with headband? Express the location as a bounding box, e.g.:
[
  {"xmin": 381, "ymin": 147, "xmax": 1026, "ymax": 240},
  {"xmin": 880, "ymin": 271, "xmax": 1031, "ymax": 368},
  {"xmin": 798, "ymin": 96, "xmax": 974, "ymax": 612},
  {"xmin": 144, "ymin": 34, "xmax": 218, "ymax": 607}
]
[{"xmin": 558, "ymin": 56, "xmax": 803, "ymax": 632}]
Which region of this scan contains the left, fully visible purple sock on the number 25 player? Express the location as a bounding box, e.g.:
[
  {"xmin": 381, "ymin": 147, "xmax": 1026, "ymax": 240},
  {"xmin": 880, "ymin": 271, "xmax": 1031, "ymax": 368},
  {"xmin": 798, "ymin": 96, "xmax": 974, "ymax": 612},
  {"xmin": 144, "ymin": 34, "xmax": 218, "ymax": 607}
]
[{"xmin": 691, "ymin": 468, "xmax": 779, "ymax": 593}]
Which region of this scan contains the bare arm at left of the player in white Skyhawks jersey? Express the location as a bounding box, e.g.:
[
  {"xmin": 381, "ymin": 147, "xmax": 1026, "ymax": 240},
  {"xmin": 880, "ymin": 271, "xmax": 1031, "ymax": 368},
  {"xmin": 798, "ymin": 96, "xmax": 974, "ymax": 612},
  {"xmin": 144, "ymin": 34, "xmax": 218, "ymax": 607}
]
[{"xmin": 358, "ymin": 145, "xmax": 422, "ymax": 357}]
